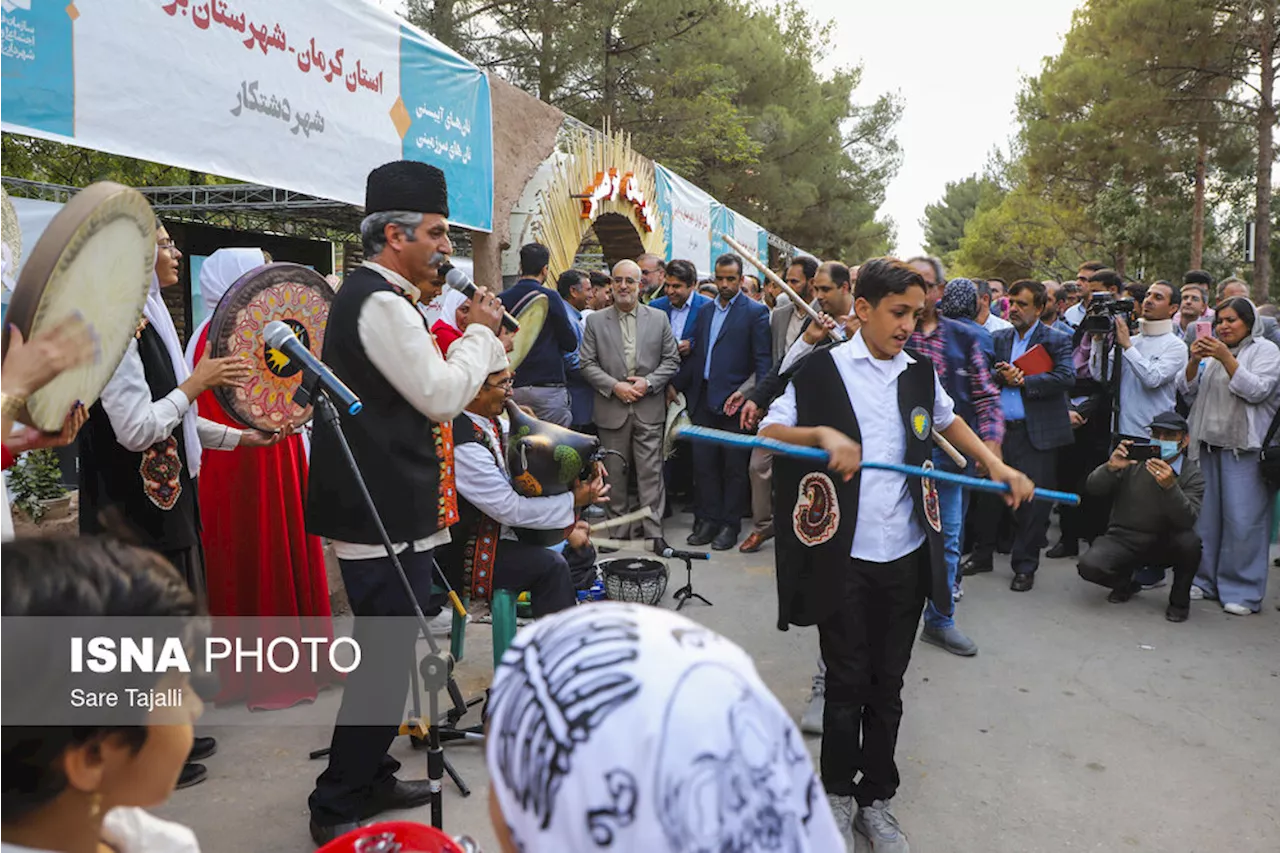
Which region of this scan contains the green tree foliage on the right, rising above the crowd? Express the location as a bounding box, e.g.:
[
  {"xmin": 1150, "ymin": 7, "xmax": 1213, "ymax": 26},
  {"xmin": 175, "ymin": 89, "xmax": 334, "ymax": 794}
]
[{"xmin": 947, "ymin": 0, "xmax": 1254, "ymax": 280}]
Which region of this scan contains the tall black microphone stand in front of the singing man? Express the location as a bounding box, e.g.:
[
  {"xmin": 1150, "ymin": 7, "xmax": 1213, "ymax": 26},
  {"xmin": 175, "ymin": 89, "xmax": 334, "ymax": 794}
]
[{"xmin": 293, "ymin": 365, "xmax": 471, "ymax": 829}]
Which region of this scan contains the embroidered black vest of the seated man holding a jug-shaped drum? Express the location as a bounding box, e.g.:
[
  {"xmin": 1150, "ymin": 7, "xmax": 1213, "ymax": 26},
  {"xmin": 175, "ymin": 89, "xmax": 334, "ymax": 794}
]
[{"xmin": 436, "ymin": 412, "xmax": 507, "ymax": 601}]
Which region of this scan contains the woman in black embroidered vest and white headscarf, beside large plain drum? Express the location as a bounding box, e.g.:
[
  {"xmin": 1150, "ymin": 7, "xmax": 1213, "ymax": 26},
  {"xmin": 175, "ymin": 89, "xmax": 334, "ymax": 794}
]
[{"xmin": 79, "ymin": 223, "xmax": 279, "ymax": 788}]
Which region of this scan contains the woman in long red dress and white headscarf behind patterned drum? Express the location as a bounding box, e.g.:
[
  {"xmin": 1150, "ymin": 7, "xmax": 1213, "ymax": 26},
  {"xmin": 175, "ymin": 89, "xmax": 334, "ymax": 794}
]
[{"xmin": 187, "ymin": 248, "xmax": 332, "ymax": 711}]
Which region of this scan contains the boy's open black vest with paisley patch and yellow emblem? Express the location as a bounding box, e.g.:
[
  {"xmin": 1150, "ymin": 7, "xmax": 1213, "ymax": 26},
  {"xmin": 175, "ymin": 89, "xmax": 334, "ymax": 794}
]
[{"xmin": 773, "ymin": 350, "xmax": 952, "ymax": 631}]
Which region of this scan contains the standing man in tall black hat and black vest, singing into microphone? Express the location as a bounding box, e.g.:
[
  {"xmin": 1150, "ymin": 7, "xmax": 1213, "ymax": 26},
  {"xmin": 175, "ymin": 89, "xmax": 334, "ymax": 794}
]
[{"xmin": 307, "ymin": 160, "xmax": 507, "ymax": 844}]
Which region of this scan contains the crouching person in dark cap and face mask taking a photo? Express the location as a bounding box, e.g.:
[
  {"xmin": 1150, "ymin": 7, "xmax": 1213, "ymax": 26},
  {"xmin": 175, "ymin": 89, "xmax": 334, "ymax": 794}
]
[{"xmin": 1078, "ymin": 411, "xmax": 1204, "ymax": 622}]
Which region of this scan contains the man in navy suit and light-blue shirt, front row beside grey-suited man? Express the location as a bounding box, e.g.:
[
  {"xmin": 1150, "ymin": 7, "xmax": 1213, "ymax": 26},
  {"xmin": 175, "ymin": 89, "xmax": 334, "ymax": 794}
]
[{"xmin": 676, "ymin": 255, "xmax": 773, "ymax": 551}]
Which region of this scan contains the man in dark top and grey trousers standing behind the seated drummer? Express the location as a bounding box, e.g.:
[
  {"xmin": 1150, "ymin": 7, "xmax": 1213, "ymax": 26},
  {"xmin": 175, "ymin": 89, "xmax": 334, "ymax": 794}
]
[{"xmin": 498, "ymin": 243, "xmax": 579, "ymax": 427}]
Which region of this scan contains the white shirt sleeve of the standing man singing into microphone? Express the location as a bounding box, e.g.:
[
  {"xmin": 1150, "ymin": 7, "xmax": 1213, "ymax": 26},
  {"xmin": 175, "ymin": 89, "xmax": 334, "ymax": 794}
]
[{"xmin": 357, "ymin": 293, "xmax": 507, "ymax": 424}]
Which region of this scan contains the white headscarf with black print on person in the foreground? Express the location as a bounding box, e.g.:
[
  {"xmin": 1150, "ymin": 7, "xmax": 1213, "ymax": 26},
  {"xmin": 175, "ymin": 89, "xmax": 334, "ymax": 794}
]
[{"xmin": 485, "ymin": 602, "xmax": 844, "ymax": 853}]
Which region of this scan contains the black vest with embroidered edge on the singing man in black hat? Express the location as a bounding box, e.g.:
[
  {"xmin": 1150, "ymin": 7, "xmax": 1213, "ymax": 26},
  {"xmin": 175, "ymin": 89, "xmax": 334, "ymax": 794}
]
[{"xmin": 307, "ymin": 268, "xmax": 458, "ymax": 544}]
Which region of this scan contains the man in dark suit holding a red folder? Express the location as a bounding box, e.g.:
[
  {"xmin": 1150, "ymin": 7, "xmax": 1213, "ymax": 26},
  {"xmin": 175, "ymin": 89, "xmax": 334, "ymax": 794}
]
[{"xmin": 975, "ymin": 280, "xmax": 1075, "ymax": 592}]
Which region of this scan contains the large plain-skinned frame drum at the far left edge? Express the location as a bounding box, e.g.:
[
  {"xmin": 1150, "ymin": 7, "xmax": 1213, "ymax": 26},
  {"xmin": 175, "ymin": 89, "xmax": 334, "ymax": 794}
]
[{"xmin": 0, "ymin": 182, "xmax": 156, "ymax": 432}]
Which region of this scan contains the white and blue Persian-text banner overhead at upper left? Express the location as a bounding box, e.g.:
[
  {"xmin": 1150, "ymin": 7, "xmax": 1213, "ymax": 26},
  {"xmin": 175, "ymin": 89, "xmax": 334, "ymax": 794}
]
[{"xmin": 0, "ymin": 0, "xmax": 494, "ymax": 231}]
